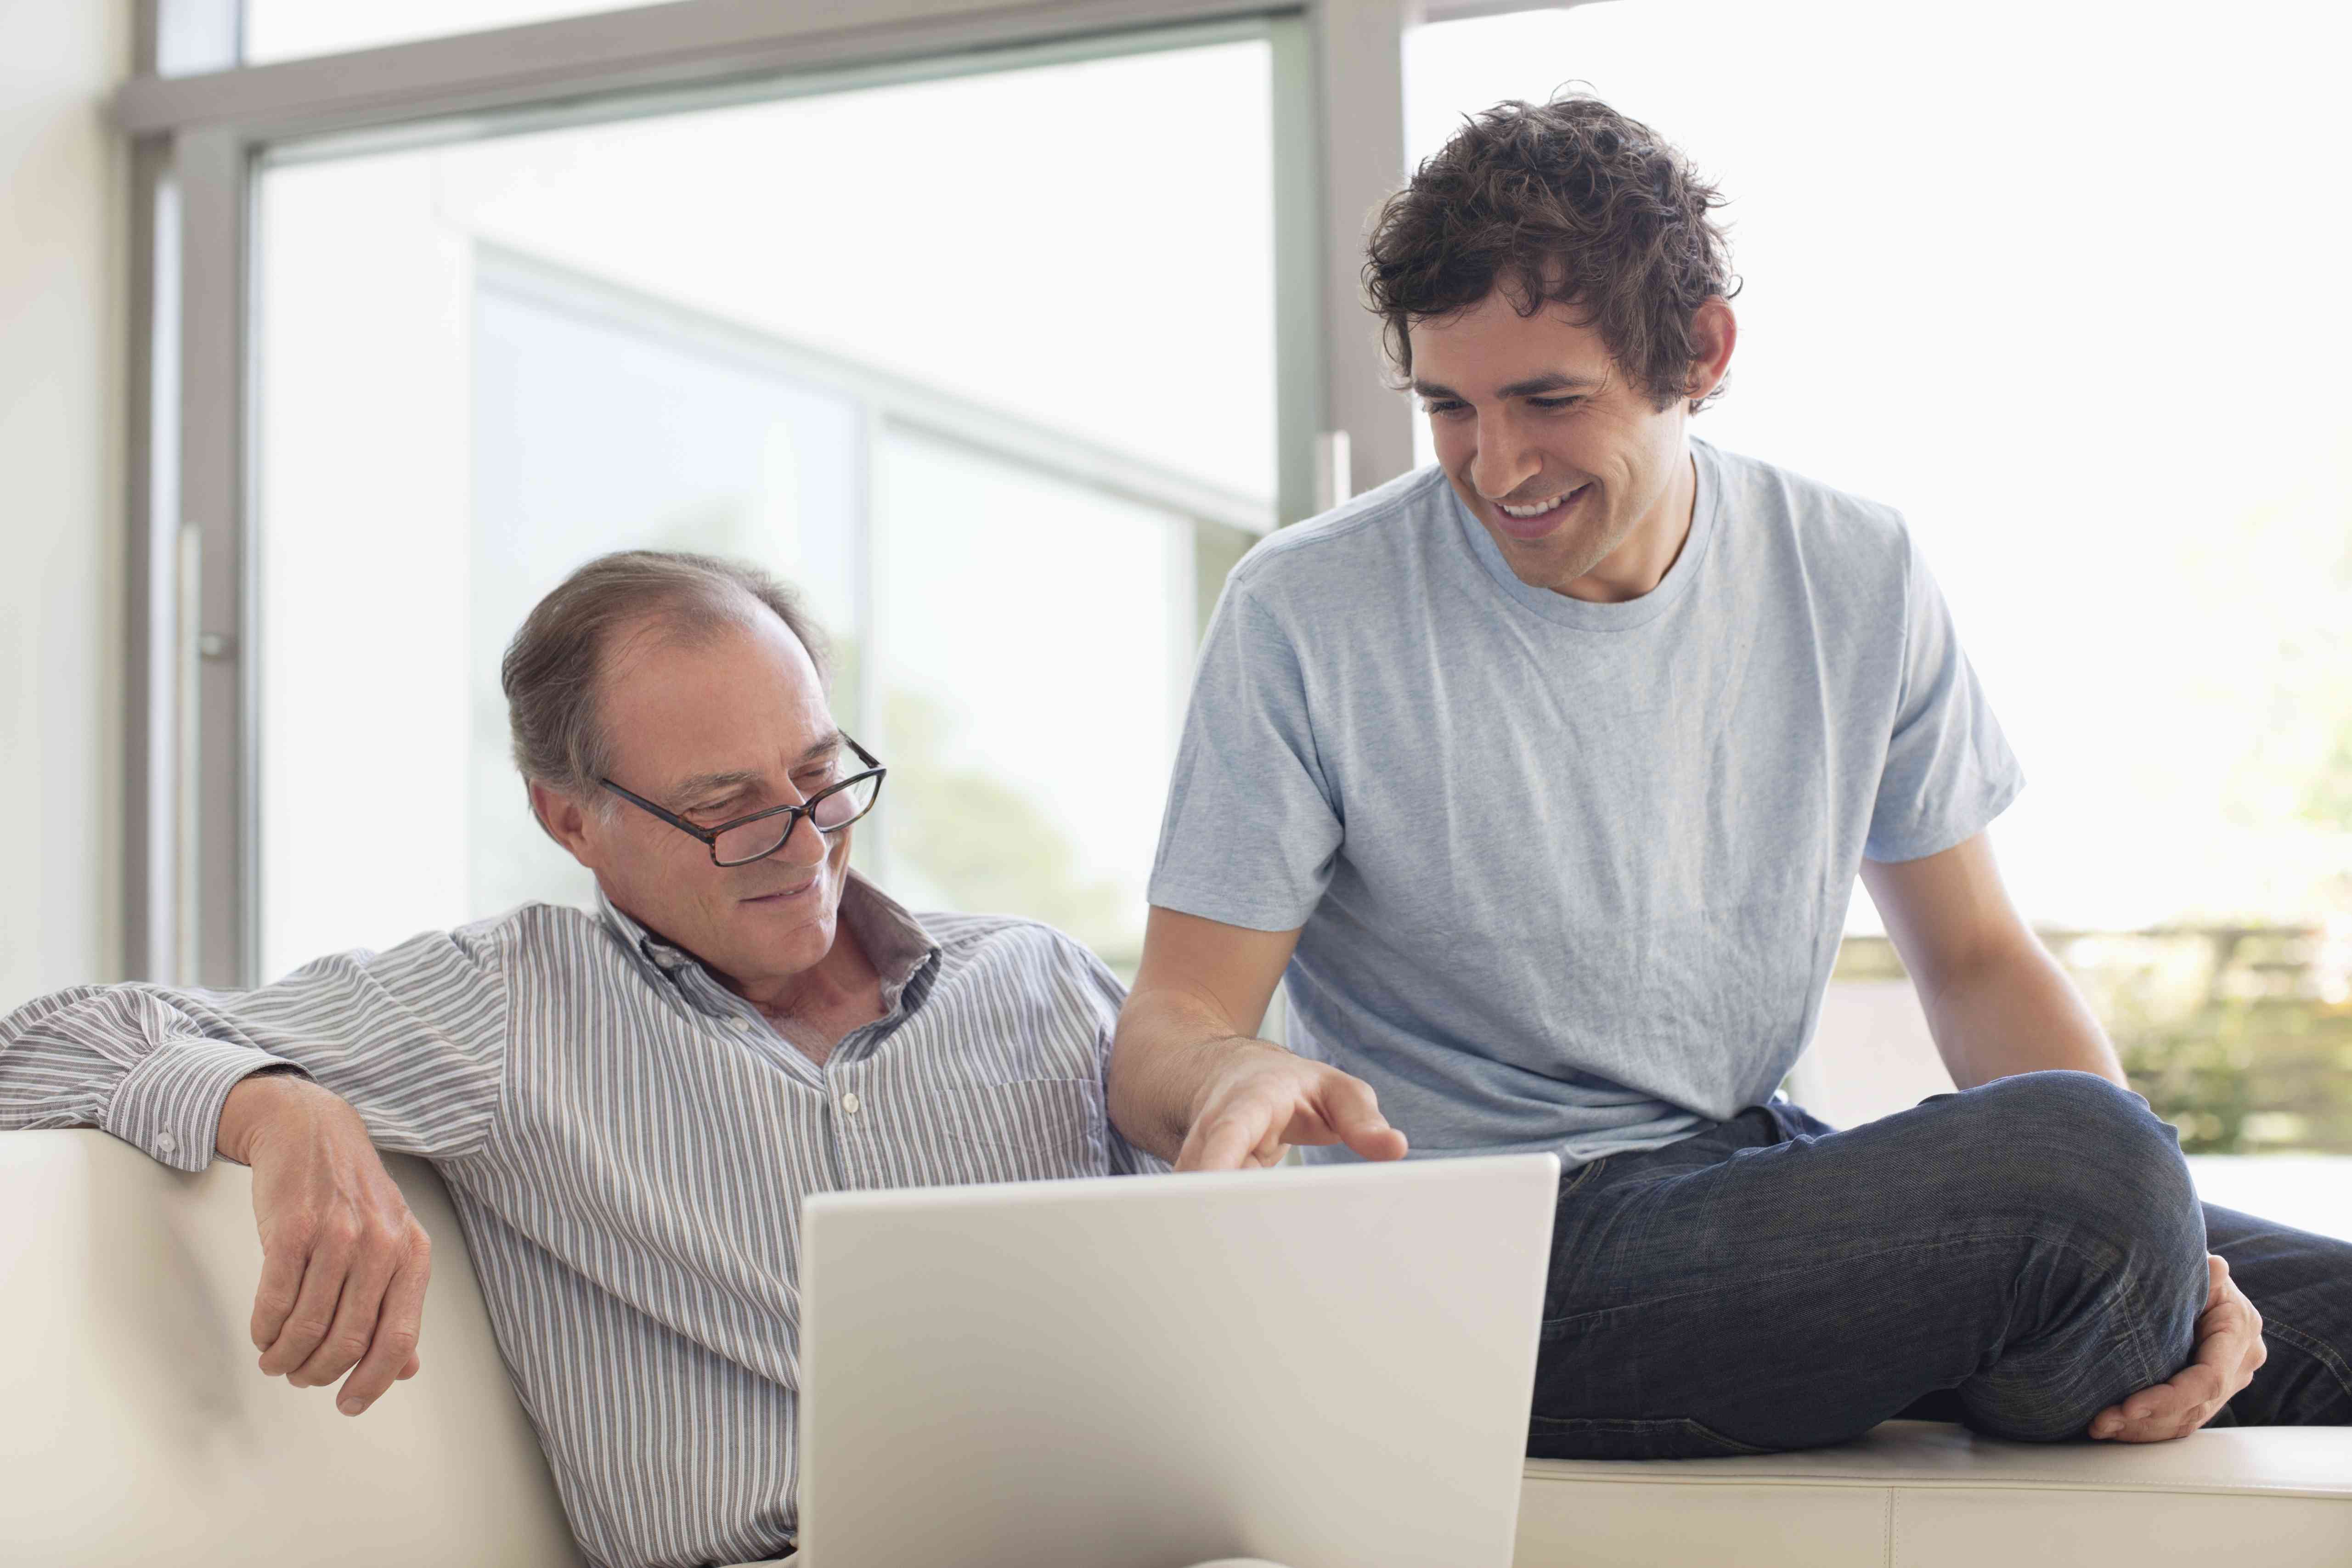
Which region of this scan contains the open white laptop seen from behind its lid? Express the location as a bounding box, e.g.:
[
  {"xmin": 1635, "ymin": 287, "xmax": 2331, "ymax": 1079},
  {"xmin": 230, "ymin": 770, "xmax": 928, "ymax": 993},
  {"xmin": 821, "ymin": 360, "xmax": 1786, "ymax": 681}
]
[{"xmin": 800, "ymin": 1154, "xmax": 1559, "ymax": 1568}]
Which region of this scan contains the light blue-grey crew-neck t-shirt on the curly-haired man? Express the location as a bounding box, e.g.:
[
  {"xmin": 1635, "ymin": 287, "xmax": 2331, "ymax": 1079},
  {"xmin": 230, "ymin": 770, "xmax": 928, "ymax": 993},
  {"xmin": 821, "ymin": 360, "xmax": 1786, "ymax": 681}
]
[{"xmin": 1150, "ymin": 440, "xmax": 2023, "ymax": 1164}]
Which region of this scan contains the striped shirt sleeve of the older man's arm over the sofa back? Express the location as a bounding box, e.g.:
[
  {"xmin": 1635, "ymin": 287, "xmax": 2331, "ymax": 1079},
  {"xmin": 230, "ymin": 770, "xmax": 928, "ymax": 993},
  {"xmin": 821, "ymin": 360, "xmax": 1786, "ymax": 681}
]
[{"xmin": 0, "ymin": 931, "xmax": 508, "ymax": 1171}]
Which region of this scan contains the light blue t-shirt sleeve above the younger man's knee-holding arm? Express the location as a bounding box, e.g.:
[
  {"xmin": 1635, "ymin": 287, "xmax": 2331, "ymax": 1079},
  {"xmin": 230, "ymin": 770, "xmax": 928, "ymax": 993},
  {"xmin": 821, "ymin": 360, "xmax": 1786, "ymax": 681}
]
[{"xmin": 1863, "ymin": 538, "xmax": 2025, "ymax": 860}]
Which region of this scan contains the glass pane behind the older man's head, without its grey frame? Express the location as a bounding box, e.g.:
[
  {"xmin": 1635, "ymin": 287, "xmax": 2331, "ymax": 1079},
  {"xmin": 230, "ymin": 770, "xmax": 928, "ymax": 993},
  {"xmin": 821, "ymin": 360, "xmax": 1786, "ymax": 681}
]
[{"xmin": 254, "ymin": 38, "xmax": 1277, "ymax": 976}]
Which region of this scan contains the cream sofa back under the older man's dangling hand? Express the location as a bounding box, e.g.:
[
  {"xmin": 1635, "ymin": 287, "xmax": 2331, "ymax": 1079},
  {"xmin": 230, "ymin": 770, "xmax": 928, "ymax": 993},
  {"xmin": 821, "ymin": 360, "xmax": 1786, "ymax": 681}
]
[{"xmin": 0, "ymin": 1131, "xmax": 579, "ymax": 1568}]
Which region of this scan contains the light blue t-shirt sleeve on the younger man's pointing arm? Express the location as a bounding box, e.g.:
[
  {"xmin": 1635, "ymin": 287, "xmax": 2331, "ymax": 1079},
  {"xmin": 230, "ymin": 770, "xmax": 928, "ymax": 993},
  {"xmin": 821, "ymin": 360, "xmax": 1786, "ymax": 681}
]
[{"xmin": 1150, "ymin": 583, "xmax": 1343, "ymax": 931}]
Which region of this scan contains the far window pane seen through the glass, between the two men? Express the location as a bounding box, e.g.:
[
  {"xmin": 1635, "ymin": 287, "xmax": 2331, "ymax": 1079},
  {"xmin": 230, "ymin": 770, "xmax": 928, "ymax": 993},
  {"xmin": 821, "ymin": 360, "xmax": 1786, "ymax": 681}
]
[{"xmin": 877, "ymin": 433, "xmax": 1195, "ymax": 969}]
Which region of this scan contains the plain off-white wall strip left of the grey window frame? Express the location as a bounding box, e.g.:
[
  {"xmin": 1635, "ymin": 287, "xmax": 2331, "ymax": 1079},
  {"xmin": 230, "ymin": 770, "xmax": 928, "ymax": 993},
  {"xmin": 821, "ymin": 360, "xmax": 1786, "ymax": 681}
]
[{"xmin": 0, "ymin": 0, "xmax": 132, "ymax": 1011}]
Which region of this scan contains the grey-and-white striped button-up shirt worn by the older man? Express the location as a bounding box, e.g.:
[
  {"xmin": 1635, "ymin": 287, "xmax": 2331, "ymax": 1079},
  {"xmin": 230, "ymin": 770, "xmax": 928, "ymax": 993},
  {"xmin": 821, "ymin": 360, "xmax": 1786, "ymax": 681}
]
[{"xmin": 0, "ymin": 877, "xmax": 1164, "ymax": 1568}]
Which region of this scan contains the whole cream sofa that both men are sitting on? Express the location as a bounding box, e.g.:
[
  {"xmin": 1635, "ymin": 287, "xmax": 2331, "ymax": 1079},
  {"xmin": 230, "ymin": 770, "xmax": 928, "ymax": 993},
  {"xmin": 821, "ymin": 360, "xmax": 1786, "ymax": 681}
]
[{"xmin": 14, "ymin": 1133, "xmax": 2352, "ymax": 1568}]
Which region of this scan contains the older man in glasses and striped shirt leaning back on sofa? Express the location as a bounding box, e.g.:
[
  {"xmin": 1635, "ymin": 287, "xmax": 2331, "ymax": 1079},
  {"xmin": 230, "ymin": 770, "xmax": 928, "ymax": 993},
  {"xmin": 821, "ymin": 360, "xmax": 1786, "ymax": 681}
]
[{"xmin": 0, "ymin": 553, "xmax": 1145, "ymax": 1566}]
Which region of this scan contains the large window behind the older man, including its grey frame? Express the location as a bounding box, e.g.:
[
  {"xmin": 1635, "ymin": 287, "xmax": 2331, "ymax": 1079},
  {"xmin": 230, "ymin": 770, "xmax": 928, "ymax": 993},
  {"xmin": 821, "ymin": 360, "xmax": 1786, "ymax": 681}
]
[{"xmin": 129, "ymin": 0, "xmax": 1402, "ymax": 985}]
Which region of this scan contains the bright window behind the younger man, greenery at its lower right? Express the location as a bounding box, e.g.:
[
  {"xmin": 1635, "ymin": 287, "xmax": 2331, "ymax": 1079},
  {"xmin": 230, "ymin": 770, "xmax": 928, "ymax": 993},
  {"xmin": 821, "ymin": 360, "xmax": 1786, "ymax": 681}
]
[{"xmin": 1409, "ymin": 0, "xmax": 2352, "ymax": 1175}]
